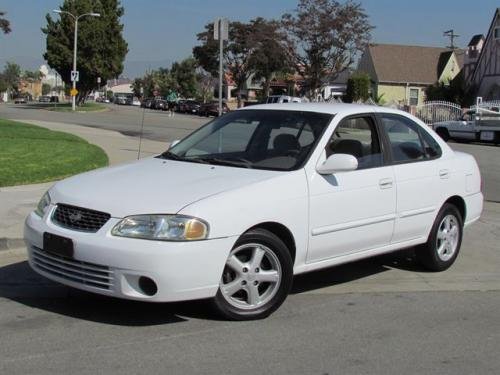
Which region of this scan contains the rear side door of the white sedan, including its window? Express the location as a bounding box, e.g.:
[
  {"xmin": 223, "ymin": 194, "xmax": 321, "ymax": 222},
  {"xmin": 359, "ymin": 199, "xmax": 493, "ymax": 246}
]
[{"xmin": 379, "ymin": 113, "xmax": 442, "ymax": 243}]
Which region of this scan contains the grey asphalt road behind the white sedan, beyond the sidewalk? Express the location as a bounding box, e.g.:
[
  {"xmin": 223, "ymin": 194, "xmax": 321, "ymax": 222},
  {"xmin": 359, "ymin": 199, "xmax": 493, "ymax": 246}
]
[{"xmin": 0, "ymin": 104, "xmax": 500, "ymax": 202}]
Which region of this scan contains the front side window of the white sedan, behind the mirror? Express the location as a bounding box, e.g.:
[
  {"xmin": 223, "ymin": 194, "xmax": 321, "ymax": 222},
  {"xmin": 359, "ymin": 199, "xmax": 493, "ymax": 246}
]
[{"xmin": 326, "ymin": 116, "xmax": 383, "ymax": 169}]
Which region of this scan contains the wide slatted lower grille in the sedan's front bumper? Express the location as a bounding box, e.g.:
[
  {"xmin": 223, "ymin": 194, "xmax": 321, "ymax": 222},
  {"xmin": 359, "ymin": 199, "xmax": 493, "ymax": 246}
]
[{"xmin": 32, "ymin": 247, "xmax": 113, "ymax": 290}]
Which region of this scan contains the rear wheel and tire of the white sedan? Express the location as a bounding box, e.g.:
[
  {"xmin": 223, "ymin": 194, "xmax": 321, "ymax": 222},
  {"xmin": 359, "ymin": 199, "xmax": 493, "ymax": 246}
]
[{"xmin": 415, "ymin": 203, "xmax": 463, "ymax": 272}]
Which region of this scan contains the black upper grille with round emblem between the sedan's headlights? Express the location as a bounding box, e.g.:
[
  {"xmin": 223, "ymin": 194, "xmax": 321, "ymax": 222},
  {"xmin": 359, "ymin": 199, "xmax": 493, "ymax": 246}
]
[{"xmin": 52, "ymin": 204, "xmax": 111, "ymax": 232}]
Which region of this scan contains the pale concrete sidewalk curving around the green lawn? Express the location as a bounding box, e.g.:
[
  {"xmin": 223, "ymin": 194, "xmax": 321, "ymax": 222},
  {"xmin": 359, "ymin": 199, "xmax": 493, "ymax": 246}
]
[{"xmin": 0, "ymin": 120, "xmax": 168, "ymax": 251}]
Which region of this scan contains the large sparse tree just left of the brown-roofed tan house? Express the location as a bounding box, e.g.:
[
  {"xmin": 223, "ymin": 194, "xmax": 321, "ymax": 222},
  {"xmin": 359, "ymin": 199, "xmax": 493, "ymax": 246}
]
[{"xmin": 282, "ymin": 0, "xmax": 373, "ymax": 98}]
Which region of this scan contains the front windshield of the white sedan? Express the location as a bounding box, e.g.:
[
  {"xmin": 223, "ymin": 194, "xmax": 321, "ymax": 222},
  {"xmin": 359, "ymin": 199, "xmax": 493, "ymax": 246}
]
[{"xmin": 159, "ymin": 110, "xmax": 333, "ymax": 171}]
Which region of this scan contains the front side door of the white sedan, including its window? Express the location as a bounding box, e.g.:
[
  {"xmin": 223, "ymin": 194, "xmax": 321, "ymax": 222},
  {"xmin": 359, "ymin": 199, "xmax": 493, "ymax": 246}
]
[{"xmin": 307, "ymin": 114, "xmax": 396, "ymax": 263}]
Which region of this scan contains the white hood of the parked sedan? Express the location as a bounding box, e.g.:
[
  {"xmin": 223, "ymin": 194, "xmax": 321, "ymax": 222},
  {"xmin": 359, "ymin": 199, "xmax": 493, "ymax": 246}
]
[{"xmin": 49, "ymin": 158, "xmax": 283, "ymax": 218}]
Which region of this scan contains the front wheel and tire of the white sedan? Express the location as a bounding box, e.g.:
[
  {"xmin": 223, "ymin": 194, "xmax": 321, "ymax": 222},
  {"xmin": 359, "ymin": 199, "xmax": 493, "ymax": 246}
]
[{"xmin": 213, "ymin": 229, "xmax": 293, "ymax": 320}]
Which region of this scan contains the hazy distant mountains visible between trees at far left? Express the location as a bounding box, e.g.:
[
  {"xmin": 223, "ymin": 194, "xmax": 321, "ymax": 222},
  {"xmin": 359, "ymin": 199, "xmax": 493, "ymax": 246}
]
[{"xmin": 0, "ymin": 56, "xmax": 172, "ymax": 79}]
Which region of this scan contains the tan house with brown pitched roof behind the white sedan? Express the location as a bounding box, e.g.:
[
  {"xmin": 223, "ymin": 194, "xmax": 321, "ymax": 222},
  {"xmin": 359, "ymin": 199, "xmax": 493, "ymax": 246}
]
[{"xmin": 358, "ymin": 44, "xmax": 464, "ymax": 105}]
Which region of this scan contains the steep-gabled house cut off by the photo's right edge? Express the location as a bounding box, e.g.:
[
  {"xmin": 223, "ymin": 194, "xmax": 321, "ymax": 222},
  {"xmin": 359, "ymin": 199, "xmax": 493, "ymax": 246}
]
[{"xmin": 467, "ymin": 8, "xmax": 500, "ymax": 100}]
